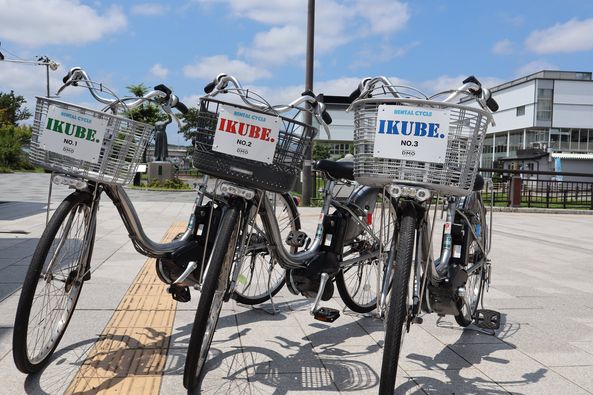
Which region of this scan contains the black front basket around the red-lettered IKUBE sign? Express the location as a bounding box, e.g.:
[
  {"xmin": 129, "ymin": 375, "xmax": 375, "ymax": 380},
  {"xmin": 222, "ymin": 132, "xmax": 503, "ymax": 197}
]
[{"xmin": 193, "ymin": 99, "xmax": 316, "ymax": 192}]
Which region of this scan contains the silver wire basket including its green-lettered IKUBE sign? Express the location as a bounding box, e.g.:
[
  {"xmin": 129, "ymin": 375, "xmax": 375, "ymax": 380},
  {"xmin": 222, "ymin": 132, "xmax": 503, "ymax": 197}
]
[{"xmin": 30, "ymin": 97, "xmax": 154, "ymax": 185}]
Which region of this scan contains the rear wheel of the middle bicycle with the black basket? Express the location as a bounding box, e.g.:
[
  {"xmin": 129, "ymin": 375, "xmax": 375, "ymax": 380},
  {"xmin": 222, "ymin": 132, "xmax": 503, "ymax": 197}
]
[{"xmin": 335, "ymin": 195, "xmax": 395, "ymax": 313}]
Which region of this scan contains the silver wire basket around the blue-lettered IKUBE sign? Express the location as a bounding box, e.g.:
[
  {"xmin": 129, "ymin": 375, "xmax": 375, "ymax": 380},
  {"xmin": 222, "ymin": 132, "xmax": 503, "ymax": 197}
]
[{"xmin": 352, "ymin": 98, "xmax": 491, "ymax": 196}]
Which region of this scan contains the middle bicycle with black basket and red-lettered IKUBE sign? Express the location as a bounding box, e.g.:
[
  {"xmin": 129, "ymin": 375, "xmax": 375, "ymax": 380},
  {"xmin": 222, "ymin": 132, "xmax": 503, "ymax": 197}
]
[{"xmin": 183, "ymin": 74, "xmax": 394, "ymax": 389}]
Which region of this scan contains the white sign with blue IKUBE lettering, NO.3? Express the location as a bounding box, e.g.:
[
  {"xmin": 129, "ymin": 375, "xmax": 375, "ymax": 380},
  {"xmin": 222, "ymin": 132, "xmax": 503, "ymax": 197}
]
[{"xmin": 373, "ymin": 104, "xmax": 449, "ymax": 163}]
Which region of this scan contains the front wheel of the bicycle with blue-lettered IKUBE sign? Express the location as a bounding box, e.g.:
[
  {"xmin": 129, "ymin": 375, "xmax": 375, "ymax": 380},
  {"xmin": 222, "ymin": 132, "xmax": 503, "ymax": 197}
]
[{"xmin": 379, "ymin": 203, "xmax": 416, "ymax": 394}]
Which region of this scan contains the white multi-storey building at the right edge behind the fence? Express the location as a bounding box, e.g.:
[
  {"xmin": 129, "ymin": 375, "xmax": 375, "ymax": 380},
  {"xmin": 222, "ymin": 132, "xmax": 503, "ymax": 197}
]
[{"xmin": 481, "ymin": 70, "xmax": 593, "ymax": 177}]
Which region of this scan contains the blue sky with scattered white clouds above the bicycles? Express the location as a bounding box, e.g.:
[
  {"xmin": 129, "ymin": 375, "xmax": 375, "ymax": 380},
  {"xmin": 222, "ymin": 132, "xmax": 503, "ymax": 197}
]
[{"xmin": 0, "ymin": 0, "xmax": 593, "ymax": 143}]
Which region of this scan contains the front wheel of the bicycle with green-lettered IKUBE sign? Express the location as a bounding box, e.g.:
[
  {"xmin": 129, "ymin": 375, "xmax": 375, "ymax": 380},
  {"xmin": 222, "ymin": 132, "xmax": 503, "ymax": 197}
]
[{"xmin": 12, "ymin": 192, "xmax": 96, "ymax": 373}]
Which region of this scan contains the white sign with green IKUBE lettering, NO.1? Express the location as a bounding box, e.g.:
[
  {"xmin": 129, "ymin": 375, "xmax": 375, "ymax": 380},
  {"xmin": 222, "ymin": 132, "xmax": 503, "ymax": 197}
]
[{"xmin": 39, "ymin": 105, "xmax": 107, "ymax": 163}]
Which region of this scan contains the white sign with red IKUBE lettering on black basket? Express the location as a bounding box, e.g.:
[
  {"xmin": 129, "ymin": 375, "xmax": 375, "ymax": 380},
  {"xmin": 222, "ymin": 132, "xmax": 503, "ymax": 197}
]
[{"xmin": 212, "ymin": 104, "xmax": 280, "ymax": 164}]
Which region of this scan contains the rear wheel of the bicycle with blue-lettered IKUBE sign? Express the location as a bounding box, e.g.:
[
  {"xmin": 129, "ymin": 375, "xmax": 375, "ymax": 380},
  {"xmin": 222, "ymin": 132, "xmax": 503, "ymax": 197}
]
[{"xmin": 455, "ymin": 198, "xmax": 488, "ymax": 327}]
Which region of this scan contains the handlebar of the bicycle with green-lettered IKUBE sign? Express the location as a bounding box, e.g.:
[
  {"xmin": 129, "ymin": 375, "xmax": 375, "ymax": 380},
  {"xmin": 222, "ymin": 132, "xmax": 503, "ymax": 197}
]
[{"xmin": 57, "ymin": 67, "xmax": 188, "ymax": 127}]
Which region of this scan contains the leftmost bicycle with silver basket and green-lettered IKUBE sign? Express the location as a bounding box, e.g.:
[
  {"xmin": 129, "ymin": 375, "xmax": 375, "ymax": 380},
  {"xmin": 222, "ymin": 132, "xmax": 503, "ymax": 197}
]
[{"xmin": 12, "ymin": 67, "xmax": 292, "ymax": 373}]
